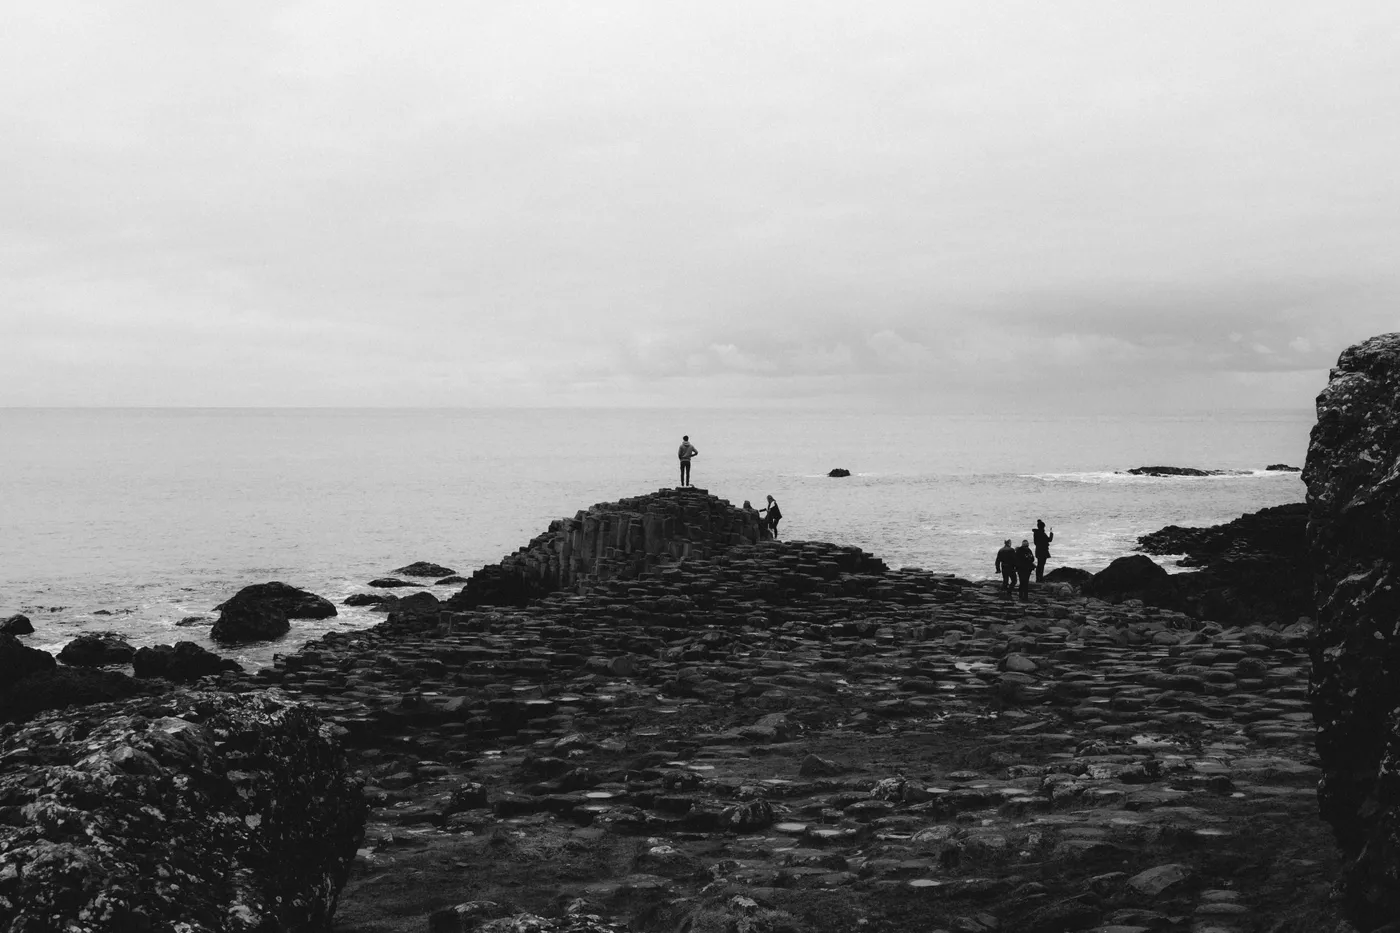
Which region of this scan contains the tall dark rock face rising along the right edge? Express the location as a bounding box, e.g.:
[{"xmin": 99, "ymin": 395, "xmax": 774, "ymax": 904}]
[{"xmin": 1303, "ymin": 333, "xmax": 1400, "ymax": 930}]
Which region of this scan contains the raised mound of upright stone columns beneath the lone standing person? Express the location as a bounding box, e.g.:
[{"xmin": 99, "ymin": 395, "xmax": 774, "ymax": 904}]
[{"xmin": 448, "ymin": 486, "xmax": 769, "ymax": 609}]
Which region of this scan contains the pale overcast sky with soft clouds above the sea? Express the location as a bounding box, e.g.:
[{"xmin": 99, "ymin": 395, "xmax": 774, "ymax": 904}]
[{"xmin": 0, "ymin": 0, "xmax": 1400, "ymax": 413}]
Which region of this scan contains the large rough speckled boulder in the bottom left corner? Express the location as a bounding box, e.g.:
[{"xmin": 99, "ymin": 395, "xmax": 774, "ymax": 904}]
[{"xmin": 0, "ymin": 692, "xmax": 365, "ymax": 933}]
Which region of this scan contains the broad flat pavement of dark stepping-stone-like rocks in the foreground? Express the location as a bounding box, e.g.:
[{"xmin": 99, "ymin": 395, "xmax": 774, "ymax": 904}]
[{"xmin": 218, "ymin": 501, "xmax": 1337, "ymax": 933}]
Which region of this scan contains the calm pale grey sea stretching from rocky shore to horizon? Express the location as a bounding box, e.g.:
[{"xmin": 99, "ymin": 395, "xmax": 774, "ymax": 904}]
[{"xmin": 0, "ymin": 409, "xmax": 1313, "ymax": 665}]
